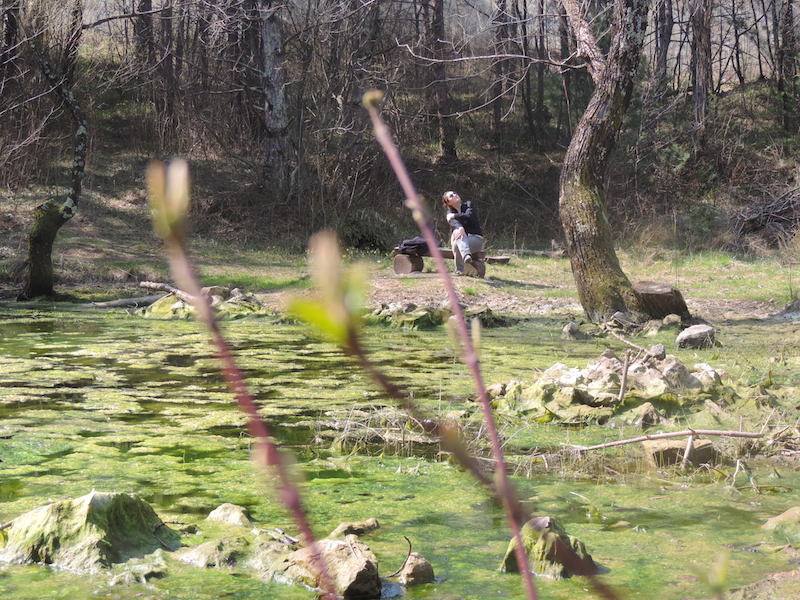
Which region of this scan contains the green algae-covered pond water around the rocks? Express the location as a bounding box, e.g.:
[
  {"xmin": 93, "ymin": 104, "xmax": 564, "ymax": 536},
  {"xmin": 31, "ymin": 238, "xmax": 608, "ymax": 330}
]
[{"xmin": 0, "ymin": 304, "xmax": 800, "ymax": 600}]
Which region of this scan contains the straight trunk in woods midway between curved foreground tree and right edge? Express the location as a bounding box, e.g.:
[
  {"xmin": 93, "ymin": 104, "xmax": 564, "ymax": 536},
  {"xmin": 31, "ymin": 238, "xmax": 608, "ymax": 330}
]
[{"xmin": 691, "ymin": 0, "xmax": 711, "ymax": 155}]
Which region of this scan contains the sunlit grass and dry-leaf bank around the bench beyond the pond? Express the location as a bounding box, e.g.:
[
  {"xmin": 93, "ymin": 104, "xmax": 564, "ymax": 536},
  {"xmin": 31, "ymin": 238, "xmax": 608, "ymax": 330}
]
[{"xmin": 0, "ymin": 184, "xmax": 800, "ymax": 322}]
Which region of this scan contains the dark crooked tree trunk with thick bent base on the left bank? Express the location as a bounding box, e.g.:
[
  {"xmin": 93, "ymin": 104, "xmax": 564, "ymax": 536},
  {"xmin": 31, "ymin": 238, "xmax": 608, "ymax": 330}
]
[{"xmin": 20, "ymin": 2, "xmax": 87, "ymax": 299}]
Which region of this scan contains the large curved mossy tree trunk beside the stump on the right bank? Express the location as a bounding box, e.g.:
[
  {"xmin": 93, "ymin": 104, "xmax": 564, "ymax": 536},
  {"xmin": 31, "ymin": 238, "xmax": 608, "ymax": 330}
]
[{"xmin": 559, "ymin": 0, "xmax": 647, "ymax": 322}]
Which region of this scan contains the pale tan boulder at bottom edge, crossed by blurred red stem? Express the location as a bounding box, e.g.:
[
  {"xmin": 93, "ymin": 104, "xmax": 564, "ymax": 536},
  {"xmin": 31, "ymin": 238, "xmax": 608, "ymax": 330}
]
[{"xmin": 271, "ymin": 535, "xmax": 381, "ymax": 600}]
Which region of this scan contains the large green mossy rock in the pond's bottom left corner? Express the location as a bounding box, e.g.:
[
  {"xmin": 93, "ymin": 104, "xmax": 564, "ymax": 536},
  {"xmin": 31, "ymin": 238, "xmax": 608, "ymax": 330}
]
[{"xmin": 0, "ymin": 490, "xmax": 181, "ymax": 573}]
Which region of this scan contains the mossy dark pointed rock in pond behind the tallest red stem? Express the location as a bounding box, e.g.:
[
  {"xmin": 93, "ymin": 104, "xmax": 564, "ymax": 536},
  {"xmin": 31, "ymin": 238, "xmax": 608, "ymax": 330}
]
[{"xmin": 500, "ymin": 517, "xmax": 597, "ymax": 579}]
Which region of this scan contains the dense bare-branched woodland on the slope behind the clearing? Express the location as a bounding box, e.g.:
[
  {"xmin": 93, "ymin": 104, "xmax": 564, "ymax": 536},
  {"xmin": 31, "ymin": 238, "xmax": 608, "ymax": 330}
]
[{"xmin": 0, "ymin": 0, "xmax": 800, "ymax": 252}]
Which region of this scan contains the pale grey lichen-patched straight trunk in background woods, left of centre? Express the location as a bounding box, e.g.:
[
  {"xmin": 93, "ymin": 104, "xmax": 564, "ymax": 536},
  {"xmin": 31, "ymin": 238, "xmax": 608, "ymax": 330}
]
[{"xmin": 258, "ymin": 0, "xmax": 289, "ymax": 200}]
